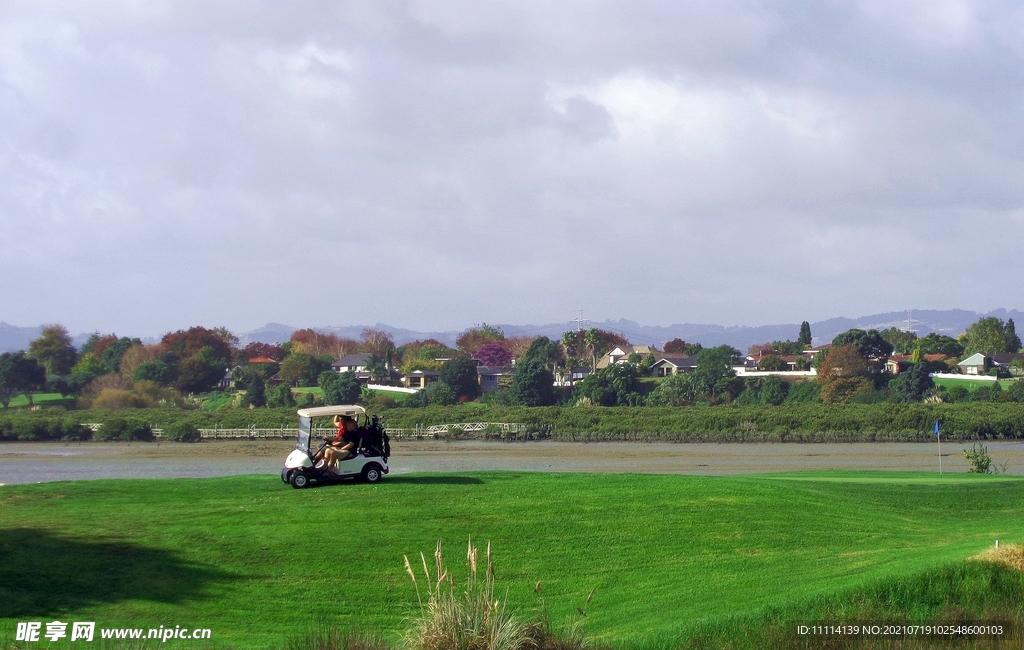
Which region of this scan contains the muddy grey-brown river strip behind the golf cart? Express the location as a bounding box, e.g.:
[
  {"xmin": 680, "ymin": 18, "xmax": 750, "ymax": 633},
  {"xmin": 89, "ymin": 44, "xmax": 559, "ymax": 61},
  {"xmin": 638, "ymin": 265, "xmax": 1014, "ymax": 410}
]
[{"xmin": 0, "ymin": 440, "xmax": 1024, "ymax": 484}]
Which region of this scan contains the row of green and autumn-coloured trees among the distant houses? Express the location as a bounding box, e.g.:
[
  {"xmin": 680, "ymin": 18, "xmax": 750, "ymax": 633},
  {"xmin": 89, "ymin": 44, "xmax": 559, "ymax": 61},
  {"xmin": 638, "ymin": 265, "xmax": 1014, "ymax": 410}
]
[{"xmin": 0, "ymin": 317, "xmax": 1021, "ymax": 407}]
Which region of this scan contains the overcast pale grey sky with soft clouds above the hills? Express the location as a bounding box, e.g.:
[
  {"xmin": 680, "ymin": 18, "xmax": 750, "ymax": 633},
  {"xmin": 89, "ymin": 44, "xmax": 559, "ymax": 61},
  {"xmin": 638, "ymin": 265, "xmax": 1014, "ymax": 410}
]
[{"xmin": 0, "ymin": 0, "xmax": 1024, "ymax": 336}]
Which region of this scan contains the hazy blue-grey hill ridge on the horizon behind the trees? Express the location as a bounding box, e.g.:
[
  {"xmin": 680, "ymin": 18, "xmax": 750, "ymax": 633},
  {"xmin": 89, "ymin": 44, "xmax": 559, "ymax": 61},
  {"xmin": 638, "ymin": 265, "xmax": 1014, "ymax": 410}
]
[{"xmin": 0, "ymin": 309, "xmax": 1024, "ymax": 352}]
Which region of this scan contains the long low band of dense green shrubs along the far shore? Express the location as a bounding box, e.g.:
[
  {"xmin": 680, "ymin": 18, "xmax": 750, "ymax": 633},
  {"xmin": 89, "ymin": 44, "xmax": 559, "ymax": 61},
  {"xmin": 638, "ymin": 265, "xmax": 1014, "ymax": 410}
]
[{"xmin": 0, "ymin": 402, "xmax": 1024, "ymax": 442}]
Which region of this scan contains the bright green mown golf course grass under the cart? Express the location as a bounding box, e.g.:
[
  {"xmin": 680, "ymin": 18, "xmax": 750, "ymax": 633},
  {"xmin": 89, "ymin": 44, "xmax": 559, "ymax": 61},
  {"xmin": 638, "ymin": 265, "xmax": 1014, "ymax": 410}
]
[{"xmin": 0, "ymin": 472, "xmax": 1024, "ymax": 648}]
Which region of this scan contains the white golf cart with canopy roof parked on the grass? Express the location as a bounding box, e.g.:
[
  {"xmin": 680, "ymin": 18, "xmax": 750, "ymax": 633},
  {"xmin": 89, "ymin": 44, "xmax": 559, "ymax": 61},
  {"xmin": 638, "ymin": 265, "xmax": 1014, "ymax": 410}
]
[{"xmin": 281, "ymin": 406, "xmax": 391, "ymax": 489}]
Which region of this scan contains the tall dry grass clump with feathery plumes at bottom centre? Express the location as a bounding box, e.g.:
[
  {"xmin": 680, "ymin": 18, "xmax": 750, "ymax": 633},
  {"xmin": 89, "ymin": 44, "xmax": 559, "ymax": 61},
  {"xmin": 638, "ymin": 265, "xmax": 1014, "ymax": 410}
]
[{"xmin": 403, "ymin": 539, "xmax": 529, "ymax": 650}]
